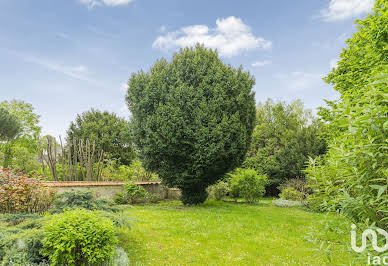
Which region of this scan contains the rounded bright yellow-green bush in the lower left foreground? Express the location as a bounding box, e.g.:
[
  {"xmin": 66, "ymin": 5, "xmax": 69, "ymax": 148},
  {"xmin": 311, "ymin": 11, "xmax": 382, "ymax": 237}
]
[{"xmin": 42, "ymin": 209, "xmax": 117, "ymax": 265}]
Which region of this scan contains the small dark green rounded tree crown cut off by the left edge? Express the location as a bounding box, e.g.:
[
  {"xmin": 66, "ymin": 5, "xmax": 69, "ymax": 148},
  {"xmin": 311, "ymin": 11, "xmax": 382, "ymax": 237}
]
[{"xmin": 0, "ymin": 107, "xmax": 22, "ymax": 141}]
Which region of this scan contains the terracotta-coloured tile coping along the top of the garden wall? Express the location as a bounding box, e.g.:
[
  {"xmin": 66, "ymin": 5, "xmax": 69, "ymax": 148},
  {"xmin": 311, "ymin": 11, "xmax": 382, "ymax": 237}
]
[{"xmin": 42, "ymin": 181, "xmax": 161, "ymax": 187}]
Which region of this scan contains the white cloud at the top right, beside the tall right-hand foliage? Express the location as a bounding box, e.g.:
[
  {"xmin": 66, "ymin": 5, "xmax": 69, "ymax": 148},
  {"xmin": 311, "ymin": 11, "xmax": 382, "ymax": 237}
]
[{"xmin": 321, "ymin": 0, "xmax": 374, "ymax": 21}]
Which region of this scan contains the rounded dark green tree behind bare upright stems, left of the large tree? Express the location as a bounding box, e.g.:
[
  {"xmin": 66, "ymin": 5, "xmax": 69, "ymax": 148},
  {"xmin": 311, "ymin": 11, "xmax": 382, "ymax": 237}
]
[{"xmin": 67, "ymin": 109, "xmax": 135, "ymax": 165}]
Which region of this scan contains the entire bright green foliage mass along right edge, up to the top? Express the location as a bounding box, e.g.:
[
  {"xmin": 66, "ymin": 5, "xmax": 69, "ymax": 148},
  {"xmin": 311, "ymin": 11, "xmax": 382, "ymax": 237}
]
[{"xmin": 307, "ymin": 0, "xmax": 388, "ymax": 228}]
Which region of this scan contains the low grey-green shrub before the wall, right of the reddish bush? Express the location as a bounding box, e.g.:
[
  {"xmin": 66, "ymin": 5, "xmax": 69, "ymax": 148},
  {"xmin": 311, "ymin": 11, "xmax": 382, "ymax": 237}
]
[{"xmin": 53, "ymin": 190, "xmax": 115, "ymax": 213}]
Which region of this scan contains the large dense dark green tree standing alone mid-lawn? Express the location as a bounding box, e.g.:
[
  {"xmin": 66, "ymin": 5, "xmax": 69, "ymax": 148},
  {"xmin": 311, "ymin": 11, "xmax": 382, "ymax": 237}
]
[{"xmin": 126, "ymin": 45, "xmax": 255, "ymax": 204}]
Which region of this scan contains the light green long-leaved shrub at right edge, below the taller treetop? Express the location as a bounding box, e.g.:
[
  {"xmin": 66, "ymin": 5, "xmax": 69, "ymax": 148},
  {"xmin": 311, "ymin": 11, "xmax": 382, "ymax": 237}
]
[{"xmin": 307, "ymin": 68, "xmax": 388, "ymax": 228}]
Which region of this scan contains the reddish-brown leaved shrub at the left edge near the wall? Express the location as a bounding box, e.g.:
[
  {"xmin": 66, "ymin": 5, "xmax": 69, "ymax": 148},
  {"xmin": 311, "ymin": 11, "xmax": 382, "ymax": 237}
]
[{"xmin": 0, "ymin": 169, "xmax": 55, "ymax": 213}]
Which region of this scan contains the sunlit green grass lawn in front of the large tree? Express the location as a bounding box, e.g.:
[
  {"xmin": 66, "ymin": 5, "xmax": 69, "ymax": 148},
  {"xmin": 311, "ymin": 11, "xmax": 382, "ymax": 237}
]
[{"xmin": 120, "ymin": 200, "xmax": 358, "ymax": 265}]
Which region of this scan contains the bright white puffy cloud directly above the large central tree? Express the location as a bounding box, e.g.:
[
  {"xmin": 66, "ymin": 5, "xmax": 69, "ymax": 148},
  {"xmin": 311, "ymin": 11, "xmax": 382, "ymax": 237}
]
[{"xmin": 152, "ymin": 16, "xmax": 272, "ymax": 57}]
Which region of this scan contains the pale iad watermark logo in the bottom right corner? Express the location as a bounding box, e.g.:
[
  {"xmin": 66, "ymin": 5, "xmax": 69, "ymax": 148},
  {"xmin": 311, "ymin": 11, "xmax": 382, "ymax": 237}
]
[{"xmin": 350, "ymin": 224, "xmax": 388, "ymax": 265}]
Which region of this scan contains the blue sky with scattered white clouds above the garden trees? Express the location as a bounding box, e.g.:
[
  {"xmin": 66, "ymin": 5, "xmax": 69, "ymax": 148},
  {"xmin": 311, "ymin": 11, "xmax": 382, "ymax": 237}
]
[{"xmin": 0, "ymin": 0, "xmax": 373, "ymax": 136}]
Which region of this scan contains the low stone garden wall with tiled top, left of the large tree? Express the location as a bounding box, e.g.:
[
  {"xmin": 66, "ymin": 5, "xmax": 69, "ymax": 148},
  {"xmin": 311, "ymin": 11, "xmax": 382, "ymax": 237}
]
[{"xmin": 43, "ymin": 181, "xmax": 180, "ymax": 199}]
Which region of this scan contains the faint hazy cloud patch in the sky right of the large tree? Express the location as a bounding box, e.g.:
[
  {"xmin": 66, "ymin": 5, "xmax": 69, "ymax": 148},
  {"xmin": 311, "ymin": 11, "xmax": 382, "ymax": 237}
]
[{"xmin": 274, "ymin": 71, "xmax": 324, "ymax": 92}]
